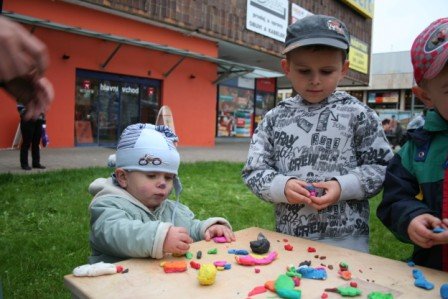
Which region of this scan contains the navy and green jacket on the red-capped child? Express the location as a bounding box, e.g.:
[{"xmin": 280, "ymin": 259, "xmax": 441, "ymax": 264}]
[{"xmin": 377, "ymin": 111, "xmax": 448, "ymax": 271}]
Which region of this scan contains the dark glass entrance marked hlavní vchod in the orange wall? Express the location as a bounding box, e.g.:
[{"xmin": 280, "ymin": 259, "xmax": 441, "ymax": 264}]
[{"xmin": 75, "ymin": 70, "xmax": 160, "ymax": 146}]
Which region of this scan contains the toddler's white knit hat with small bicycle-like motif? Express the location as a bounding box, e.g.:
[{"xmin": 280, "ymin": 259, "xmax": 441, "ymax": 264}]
[{"xmin": 115, "ymin": 123, "xmax": 180, "ymax": 175}]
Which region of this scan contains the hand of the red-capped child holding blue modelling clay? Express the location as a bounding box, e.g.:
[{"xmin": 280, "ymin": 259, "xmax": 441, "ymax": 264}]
[{"xmin": 408, "ymin": 214, "xmax": 442, "ymax": 248}]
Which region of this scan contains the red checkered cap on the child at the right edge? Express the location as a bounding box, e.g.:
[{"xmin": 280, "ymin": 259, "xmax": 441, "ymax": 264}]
[{"xmin": 411, "ymin": 18, "xmax": 448, "ymax": 84}]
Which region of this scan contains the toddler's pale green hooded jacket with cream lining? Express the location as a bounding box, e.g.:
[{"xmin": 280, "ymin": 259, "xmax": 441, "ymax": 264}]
[{"xmin": 89, "ymin": 178, "xmax": 231, "ymax": 264}]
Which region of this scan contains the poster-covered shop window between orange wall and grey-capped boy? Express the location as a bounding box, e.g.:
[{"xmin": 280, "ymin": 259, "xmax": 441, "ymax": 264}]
[{"xmin": 217, "ymin": 85, "xmax": 254, "ymax": 137}]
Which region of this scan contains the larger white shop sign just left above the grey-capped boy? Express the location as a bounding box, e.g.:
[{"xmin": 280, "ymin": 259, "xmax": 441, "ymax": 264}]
[{"xmin": 246, "ymin": 0, "xmax": 289, "ymax": 42}]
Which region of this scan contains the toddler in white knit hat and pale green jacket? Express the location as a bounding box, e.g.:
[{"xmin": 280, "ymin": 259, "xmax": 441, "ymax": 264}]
[{"xmin": 89, "ymin": 124, "xmax": 235, "ymax": 264}]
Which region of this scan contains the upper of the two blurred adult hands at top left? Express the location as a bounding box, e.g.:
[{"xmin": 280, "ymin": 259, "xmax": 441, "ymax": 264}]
[{"xmin": 0, "ymin": 16, "xmax": 49, "ymax": 82}]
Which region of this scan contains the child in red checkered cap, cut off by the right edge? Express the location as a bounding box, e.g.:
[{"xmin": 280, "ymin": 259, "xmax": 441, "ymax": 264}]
[{"xmin": 377, "ymin": 18, "xmax": 448, "ymax": 271}]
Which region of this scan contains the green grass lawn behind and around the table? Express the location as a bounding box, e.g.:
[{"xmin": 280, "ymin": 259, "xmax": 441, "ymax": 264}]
[{"xmin": 0, "ymin": 162, "xmax": 411, "ymax": 298}]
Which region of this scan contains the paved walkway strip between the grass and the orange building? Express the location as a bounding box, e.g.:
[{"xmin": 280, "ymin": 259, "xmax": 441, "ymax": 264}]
[{"xmin": 0, "ymin": 139, "xmax": 249, "ymax": 174}]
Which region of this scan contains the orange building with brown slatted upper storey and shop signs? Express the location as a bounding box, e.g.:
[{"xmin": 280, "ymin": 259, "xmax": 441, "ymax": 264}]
[{"xmin": 0, "ymin": 0, "xmax": 373, "ymax": 148}]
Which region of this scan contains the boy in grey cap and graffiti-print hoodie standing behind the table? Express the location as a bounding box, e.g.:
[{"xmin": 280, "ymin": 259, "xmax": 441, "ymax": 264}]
[{"xmin": 243, "ymin": 15, "xmax": 393, "ymax": 252}]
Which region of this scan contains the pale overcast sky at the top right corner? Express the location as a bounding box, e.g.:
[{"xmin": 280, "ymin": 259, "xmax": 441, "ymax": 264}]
[{"xmin": 372, "ymin": 0, "xmax": 448, "ymax": 53}]
